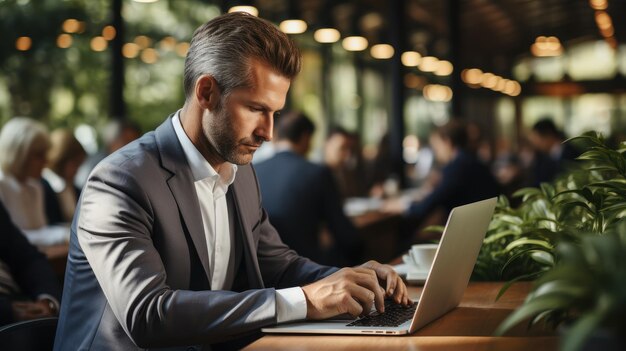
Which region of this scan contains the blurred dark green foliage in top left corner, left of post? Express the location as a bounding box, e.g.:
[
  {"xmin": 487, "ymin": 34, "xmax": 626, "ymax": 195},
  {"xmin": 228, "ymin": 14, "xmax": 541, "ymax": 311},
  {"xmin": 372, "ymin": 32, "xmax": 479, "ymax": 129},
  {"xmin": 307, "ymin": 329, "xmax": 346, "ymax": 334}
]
[{"xmin": 0, "ymin": 0, "xmax": 108, "ymax": 124}]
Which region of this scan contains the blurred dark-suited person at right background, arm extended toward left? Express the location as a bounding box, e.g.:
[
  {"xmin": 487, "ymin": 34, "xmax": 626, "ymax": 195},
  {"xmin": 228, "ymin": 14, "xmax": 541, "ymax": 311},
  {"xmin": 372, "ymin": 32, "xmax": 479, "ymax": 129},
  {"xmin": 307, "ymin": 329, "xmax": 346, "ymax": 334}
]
[{"xmin": 385, "ymin": 120, "xmax": 500, "ymax": 239}]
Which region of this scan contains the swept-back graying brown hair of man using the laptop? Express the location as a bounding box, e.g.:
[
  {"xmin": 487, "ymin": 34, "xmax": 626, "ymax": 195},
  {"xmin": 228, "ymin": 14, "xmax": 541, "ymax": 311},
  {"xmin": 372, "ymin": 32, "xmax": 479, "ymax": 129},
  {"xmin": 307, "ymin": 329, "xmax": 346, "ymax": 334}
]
[{"xmin": 183, "ymin": 12, "xmax": 301, "ymax": 99}]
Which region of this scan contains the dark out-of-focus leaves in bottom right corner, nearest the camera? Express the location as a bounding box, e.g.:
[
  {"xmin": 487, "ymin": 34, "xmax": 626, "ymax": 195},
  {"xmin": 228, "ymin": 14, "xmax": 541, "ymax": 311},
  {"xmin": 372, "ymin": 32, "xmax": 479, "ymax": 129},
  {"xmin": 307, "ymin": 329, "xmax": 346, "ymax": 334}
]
[{"xmin": 496, "ymin": 223, "xmax": 626, "ymax": 351}]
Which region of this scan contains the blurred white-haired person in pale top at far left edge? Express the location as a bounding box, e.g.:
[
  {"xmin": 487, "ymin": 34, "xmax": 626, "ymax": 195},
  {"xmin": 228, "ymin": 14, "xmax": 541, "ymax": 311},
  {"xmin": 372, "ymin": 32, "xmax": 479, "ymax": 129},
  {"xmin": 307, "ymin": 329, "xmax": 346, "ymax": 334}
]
[{"xmin": 0, "ymin": 117, "xmax": 50, "ymax": 230}]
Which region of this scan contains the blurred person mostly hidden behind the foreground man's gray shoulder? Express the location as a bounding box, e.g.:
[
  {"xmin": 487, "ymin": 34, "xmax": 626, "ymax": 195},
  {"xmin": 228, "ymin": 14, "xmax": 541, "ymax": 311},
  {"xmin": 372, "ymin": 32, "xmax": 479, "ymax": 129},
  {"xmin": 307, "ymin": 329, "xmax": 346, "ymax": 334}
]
[{"xmin": 74, "ymin": 119, "xmax": 141, "ymax": 189}]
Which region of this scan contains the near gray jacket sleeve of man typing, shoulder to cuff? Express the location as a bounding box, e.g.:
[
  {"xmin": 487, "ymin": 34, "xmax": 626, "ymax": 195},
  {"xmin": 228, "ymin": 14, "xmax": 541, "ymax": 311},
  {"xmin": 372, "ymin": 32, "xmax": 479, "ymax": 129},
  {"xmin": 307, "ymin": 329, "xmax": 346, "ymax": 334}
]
[{"xmin": 76, "ymin": 160, "xmax": 288, "ymax": 347}]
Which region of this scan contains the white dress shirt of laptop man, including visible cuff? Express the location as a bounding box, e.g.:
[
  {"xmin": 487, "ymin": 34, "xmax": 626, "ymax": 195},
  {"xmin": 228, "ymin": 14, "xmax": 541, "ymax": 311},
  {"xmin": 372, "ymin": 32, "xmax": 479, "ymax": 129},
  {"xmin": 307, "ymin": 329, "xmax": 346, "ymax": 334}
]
[{"xmin": 172, "ymin": 112, "xmax": 306, "ymax": 323}]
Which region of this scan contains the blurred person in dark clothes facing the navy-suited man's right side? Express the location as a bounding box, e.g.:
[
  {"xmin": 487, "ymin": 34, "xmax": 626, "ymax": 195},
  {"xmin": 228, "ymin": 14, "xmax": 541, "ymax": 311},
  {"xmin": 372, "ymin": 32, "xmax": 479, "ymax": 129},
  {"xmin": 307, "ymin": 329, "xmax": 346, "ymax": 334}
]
[{"xmin": 324, "ymin": 127, "xmax": 368, "ymax": 201}]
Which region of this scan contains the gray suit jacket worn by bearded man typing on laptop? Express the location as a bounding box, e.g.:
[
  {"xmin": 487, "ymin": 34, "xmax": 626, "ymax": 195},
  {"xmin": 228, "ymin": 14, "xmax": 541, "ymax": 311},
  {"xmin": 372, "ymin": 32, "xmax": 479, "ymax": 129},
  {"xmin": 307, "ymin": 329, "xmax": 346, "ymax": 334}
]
[{"xmin": 55, "ymin": 118, "xmax": 336, "ymax": 350}]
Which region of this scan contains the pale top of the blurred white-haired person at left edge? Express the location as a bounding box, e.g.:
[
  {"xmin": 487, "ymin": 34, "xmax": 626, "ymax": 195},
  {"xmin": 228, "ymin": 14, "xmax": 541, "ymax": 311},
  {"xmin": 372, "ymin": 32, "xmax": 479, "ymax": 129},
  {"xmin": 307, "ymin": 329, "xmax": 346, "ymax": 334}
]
[{"xmin": 0, "ymin": 172, "xmax": 48, "ymax": 230}]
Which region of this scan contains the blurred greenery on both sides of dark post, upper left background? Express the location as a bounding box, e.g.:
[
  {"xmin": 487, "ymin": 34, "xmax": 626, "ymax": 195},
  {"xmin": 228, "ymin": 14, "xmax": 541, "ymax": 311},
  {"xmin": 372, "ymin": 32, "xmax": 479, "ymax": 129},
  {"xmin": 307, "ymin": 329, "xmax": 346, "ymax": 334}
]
[{"xmin": 0, "ymin": 0, "xmax": 220, "ymax": 140}]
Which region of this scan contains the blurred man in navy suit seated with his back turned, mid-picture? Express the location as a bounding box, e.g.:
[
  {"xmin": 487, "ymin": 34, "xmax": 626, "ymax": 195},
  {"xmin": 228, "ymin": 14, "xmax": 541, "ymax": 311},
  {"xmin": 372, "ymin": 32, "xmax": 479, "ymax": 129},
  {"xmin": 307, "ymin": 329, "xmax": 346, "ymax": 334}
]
[{"xmin": 255, "ymin": 112, "xmax": 362, "ymax": 266}]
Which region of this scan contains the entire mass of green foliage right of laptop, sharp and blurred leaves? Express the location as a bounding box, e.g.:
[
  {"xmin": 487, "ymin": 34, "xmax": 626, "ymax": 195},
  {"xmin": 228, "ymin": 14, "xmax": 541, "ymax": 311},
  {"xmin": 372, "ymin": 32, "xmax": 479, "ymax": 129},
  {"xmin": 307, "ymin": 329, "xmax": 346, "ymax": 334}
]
[{"xmin": 486, "ymin": 132, "xmax": 626, "ymax": 351}]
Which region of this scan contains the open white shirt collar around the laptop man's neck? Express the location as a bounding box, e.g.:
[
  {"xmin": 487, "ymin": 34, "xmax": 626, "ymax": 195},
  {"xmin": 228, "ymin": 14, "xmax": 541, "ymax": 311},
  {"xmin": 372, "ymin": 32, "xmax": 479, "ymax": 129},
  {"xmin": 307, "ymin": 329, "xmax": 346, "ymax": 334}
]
[{"xmin": 172, "ymin": 110, "xmax": 237, "ymax": 187}]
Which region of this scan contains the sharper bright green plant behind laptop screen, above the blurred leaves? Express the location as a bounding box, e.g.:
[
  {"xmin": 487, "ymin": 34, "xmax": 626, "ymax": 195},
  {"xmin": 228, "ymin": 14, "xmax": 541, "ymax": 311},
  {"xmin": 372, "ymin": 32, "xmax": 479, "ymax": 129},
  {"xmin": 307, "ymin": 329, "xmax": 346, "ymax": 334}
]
[{"xmin": 473, "ymin": 132, "xmax": 626, "ymax": 281}]
